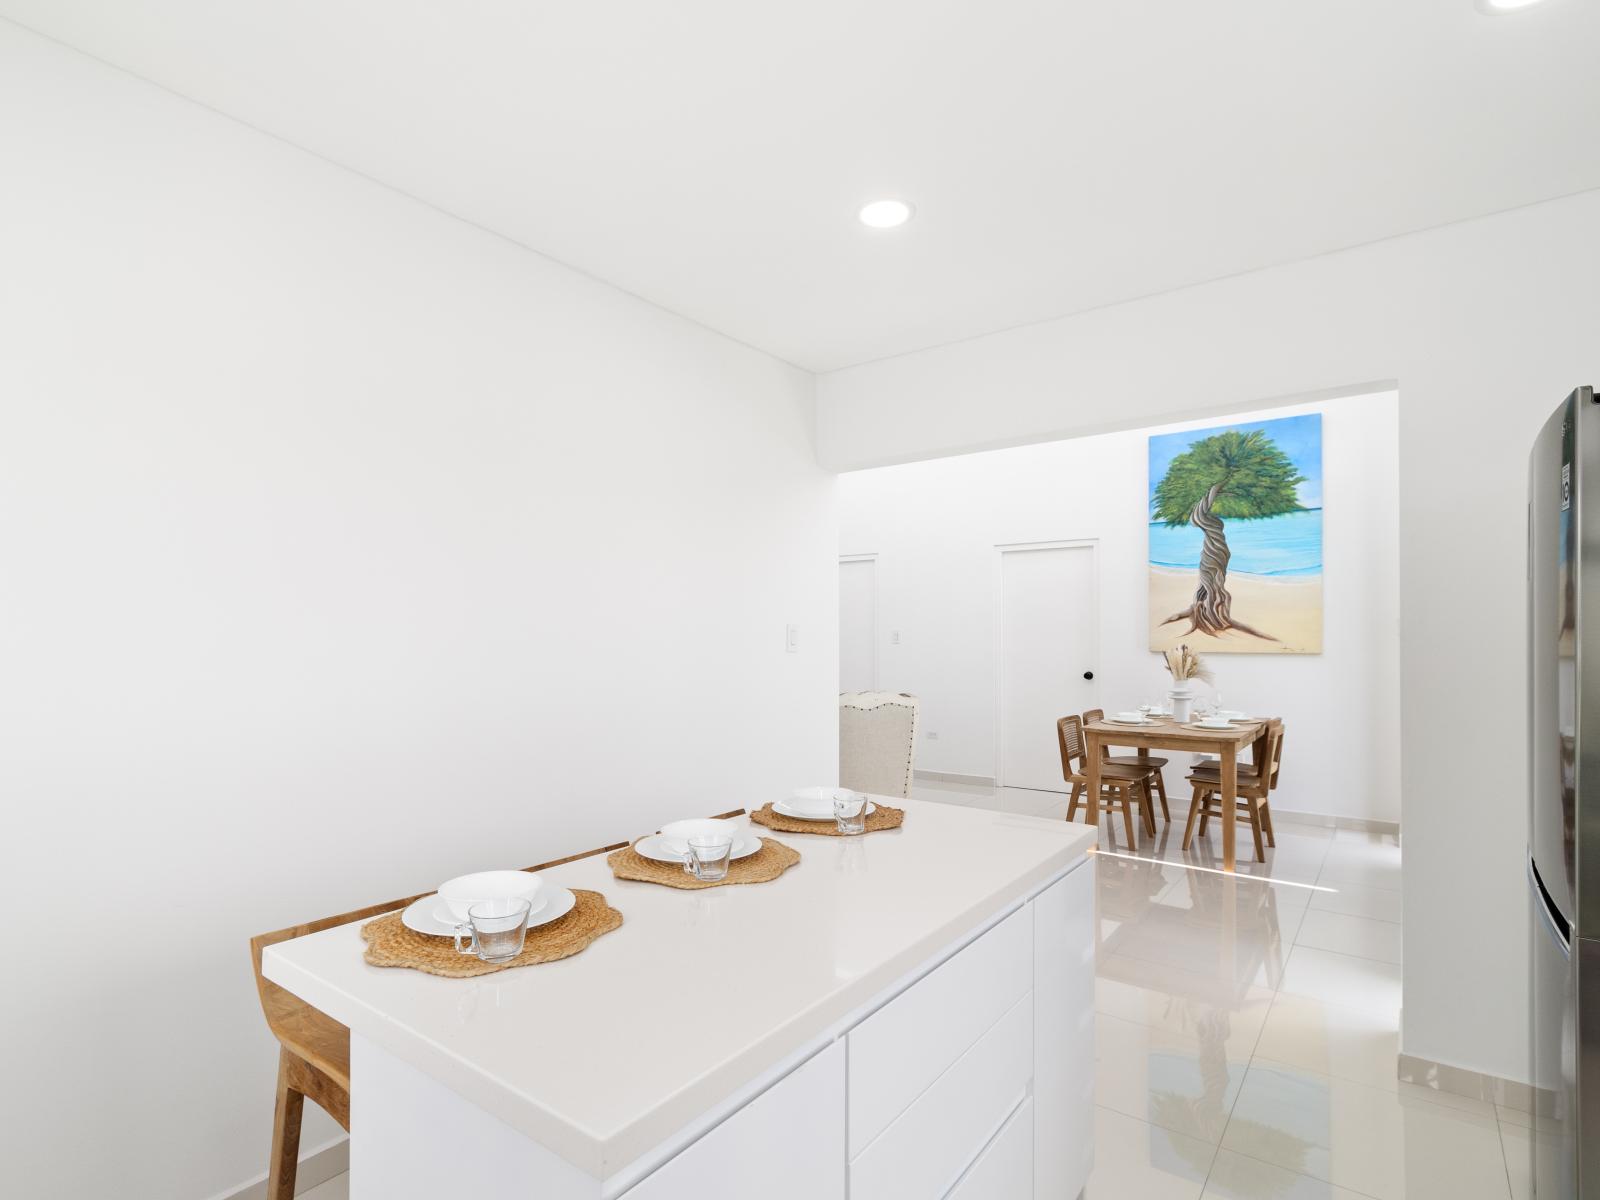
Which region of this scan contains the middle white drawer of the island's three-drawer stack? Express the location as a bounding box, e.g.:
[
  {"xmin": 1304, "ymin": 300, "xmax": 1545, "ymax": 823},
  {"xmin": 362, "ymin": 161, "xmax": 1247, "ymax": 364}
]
[{"xmin": 850, "ymin": 992, "xmax": 1034, "ymax": 1200}]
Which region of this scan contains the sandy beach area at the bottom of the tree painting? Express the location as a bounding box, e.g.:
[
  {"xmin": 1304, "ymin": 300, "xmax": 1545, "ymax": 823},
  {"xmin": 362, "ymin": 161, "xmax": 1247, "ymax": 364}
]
[{"xmin": 1149, "ymin": 566, "xmax": 1322, "ymax": 654}]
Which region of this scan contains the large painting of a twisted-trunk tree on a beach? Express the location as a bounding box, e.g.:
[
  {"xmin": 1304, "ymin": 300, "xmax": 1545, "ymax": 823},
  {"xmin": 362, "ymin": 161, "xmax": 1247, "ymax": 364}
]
[{"xmin": 1149, "ymin": 413, "xmax": 1322, "ymax": 654}]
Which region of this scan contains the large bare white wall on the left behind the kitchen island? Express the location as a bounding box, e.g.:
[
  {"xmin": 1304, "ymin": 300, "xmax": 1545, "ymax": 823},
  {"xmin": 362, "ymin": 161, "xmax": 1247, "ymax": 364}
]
[{"xmin": 0, "ymin": 22, "xmax": 837, "ymax": 1200}]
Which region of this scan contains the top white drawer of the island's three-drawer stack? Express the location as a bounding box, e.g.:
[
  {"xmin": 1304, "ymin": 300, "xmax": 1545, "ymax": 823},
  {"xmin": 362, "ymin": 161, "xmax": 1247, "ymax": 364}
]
[{"xmin": 850, "ymin": 906, "xmax": 1034, "ymax": 1158}]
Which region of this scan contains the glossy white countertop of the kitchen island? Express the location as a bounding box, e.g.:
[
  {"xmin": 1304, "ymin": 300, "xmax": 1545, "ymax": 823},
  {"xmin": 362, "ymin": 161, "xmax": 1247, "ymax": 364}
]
[{"xmin": 262, "ymin": 800, "xmax": 1094, "ymax": 1179}]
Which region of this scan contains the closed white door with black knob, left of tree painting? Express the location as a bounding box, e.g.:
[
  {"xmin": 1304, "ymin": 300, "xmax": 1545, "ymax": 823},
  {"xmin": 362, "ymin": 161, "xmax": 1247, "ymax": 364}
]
[{"xmin": 998, "ymin": 544, "xmax": 1099, "ymax": 792}]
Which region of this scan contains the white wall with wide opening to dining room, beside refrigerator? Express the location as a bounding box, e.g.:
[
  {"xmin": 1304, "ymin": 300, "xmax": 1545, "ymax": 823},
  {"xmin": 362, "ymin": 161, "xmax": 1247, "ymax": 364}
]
[{"xmin": 818, "ymin": 192, "xmax": 1600, "ymax": 1078}]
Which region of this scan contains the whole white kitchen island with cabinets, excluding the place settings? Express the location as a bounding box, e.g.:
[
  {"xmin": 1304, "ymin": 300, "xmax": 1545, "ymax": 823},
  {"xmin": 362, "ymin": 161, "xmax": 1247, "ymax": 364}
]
[{"xmin": 262, "ymin": 800, "xmax": 1094, "ymax": 1200}]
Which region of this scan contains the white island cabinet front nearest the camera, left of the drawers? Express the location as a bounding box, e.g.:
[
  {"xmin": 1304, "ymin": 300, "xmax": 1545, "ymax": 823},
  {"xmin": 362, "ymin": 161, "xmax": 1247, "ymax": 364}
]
[{"xmin": 624, "ymin": 1042, "xmax": 845, "ymax": 1200}]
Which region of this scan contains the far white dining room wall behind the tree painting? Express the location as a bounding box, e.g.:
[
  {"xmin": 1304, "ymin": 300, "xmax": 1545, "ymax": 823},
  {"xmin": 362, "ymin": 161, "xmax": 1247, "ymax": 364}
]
[{"xmin": 840, "ymin": 392, "xmax": 1400, "ymax": 821}]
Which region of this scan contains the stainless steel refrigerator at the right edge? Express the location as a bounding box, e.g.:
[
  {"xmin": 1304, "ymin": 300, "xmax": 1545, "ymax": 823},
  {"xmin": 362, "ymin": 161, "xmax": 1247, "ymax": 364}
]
[{"xmin": 1528, "ymin": 387, "xmax": 1600, "ymax": 1200}]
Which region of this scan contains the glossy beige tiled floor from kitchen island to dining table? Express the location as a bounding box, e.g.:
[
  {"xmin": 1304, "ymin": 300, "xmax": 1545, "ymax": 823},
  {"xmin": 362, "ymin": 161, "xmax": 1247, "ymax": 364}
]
[{"xmin": 917, "ymin": 787, "xmax": 1531, "ymax": 1200}]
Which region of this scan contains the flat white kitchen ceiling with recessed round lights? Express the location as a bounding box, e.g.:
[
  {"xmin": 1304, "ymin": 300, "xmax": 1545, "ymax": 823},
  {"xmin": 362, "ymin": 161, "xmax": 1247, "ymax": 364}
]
[{"xmin": 0, "ymin": 0, "xmax": 1600, "ymax": 370}]
